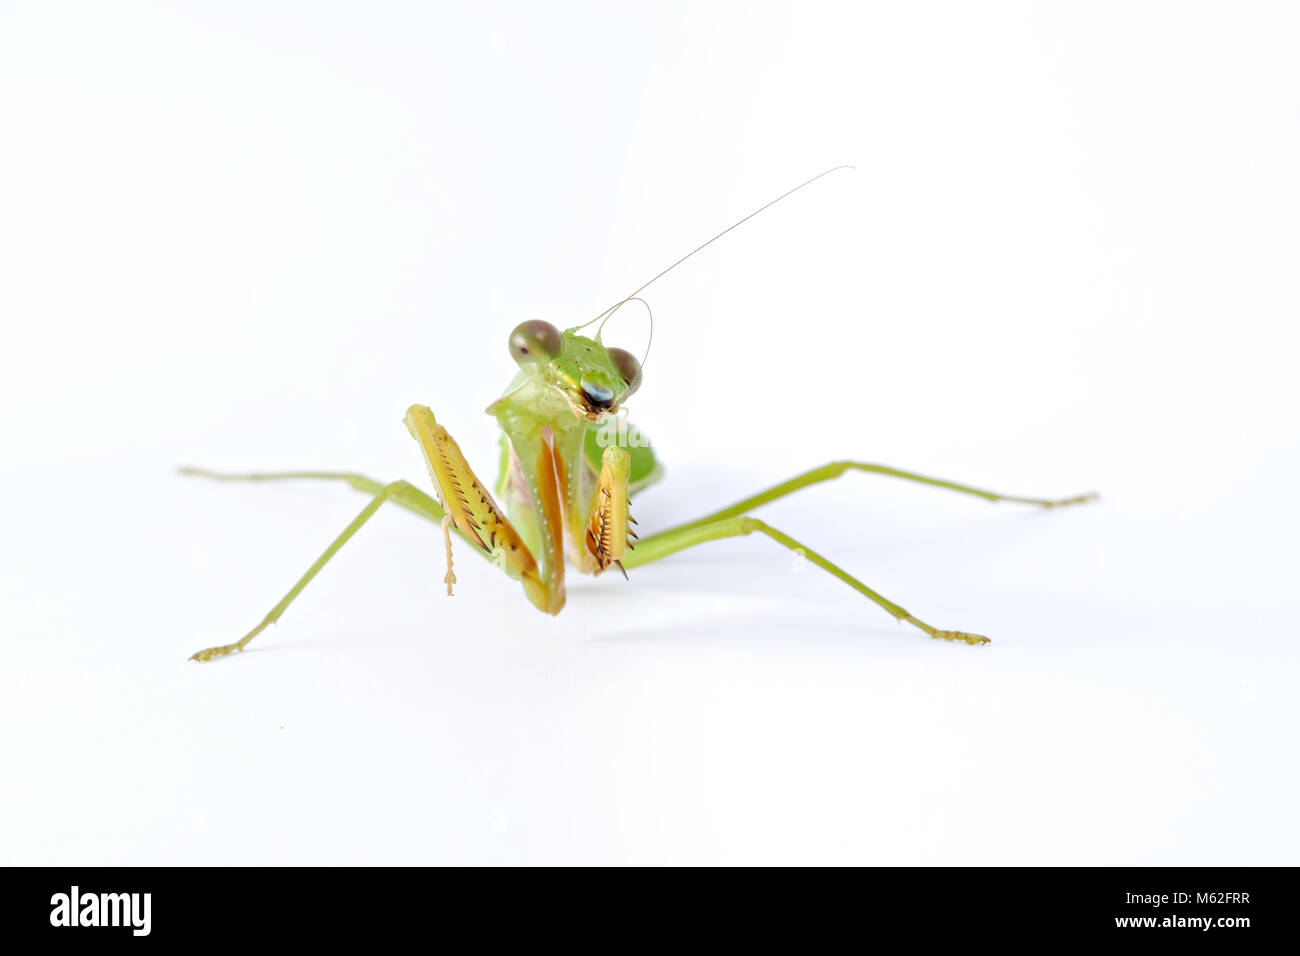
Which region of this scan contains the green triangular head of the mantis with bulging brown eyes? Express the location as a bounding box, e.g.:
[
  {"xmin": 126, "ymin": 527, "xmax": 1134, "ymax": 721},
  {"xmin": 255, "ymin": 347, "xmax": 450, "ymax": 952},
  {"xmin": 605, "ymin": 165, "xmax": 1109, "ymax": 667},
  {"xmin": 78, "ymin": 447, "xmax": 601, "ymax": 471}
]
[{"xmin": 510, "ymin": 319, "xmax": 641, "ymax": 421}]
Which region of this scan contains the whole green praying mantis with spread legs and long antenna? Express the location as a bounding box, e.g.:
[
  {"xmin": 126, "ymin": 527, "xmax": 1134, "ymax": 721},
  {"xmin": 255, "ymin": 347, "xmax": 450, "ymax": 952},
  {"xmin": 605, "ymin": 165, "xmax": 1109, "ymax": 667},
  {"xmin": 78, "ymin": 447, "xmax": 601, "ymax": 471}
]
[{"xmin": 181, "ymin": 166, "xmax": 1096, "ymax": 661}]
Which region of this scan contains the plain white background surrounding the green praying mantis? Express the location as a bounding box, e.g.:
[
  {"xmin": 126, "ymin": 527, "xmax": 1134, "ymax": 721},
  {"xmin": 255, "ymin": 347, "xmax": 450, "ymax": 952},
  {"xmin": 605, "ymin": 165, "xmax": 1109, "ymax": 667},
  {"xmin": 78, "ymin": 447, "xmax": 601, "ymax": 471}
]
[{"xmin": 0, "ymin": 1, "xmax": 1300, "ymax": 865}]
